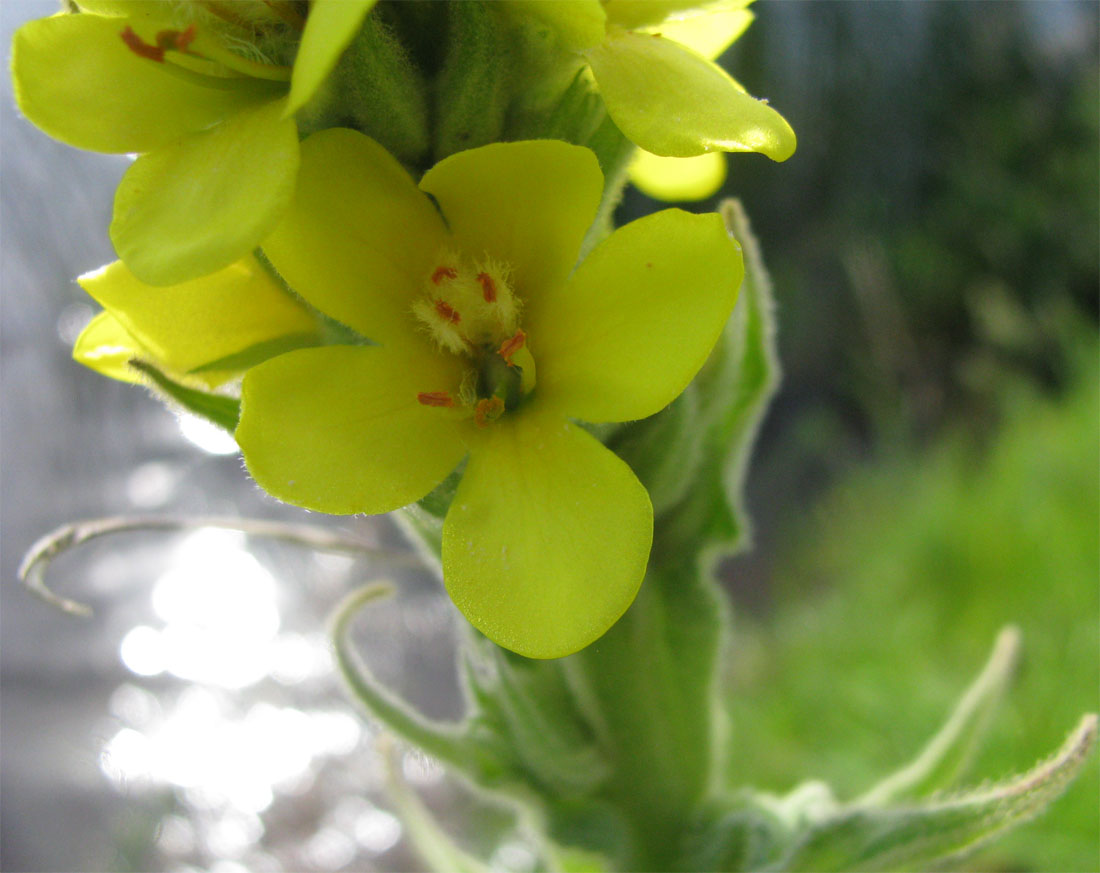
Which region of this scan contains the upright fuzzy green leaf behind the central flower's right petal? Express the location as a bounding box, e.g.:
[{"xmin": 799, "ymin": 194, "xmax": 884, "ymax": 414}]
[{"xmin": 653, "ymin": 200, "xmax": 779, "ymax": 562}]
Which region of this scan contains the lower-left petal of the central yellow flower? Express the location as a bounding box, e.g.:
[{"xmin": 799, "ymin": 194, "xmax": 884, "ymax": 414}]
[{"xmin": 237, "ymin": 345, "xmax": 465, "ymax": 515}]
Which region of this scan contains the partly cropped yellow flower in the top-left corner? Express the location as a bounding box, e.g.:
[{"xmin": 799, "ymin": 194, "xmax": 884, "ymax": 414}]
[{"xmin": 12, "ymin": 0, "xmax": 375, "ymax": 285}]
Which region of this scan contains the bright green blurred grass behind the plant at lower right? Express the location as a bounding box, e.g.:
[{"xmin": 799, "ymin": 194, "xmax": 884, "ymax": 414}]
[{"xmin": 730, "ymin": 324, "xmax": 1100, "ymax": 871}]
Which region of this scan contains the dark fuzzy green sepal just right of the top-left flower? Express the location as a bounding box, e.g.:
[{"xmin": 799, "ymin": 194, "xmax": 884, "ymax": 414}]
[{"xmin": 333, "ymin": 9, "xmax": 431, "ymax": 166}]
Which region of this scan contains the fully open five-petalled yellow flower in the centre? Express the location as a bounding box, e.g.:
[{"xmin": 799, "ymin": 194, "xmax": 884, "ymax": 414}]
[{"xmin": 237, "ymin": 129, "xmax": 743, "ymax": 657}]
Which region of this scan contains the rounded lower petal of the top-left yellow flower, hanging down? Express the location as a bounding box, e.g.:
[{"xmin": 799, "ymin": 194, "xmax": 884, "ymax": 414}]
[{"xmin": 111, "ymin": 101, "xmax": 298, "ymax": 285}]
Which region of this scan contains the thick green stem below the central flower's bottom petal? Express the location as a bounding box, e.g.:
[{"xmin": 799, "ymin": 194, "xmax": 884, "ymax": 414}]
[{"xmin": 563, "ymin": 554, "xmax": 723, "ymax": 870}]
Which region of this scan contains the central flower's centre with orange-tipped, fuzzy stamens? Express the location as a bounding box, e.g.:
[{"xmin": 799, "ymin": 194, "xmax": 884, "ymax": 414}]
[{"xmin": 413, "ymin": 252, "xmax": 535, "ymax": 427}]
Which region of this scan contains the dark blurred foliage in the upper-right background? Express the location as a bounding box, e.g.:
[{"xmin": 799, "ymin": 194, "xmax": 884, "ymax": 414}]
[{"xmin": 743, "ymin": 2, "xmax": 1100, "ymax": 431}]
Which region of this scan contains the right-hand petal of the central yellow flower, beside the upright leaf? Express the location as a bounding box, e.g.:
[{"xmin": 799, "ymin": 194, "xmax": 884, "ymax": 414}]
[{"xmin": 527, "ymin": 209, "xmax": 744, "ymax": 421}]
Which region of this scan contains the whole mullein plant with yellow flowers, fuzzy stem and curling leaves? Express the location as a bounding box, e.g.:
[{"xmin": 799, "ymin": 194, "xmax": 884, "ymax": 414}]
[{"xmin": 12, "ymin": 0, "xmax": 1096, "ymax": 871}]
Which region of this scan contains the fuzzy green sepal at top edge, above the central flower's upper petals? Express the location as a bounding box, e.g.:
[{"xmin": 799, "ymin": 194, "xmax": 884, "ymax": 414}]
[{"xmin": 432, "ymin": 0, "xmax": 510, "ymax": 161}]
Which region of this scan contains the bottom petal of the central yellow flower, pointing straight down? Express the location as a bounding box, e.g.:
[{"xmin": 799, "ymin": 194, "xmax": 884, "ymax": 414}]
[{"xmin": 443, "ymin": 413, "xmax": 653, "ymax": 657}]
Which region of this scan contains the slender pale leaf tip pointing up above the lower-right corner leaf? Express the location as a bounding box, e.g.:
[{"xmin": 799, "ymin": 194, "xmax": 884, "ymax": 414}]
[{"xmin": 856, "ymin": 628, "xmax": 1020, "ymax": 806}]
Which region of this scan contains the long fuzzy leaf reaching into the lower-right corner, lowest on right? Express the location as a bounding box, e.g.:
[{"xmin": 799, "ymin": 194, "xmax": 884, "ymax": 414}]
[{"xmin": 769, "ymin": 715, "xmax": 1097, "ymax": 873}]
